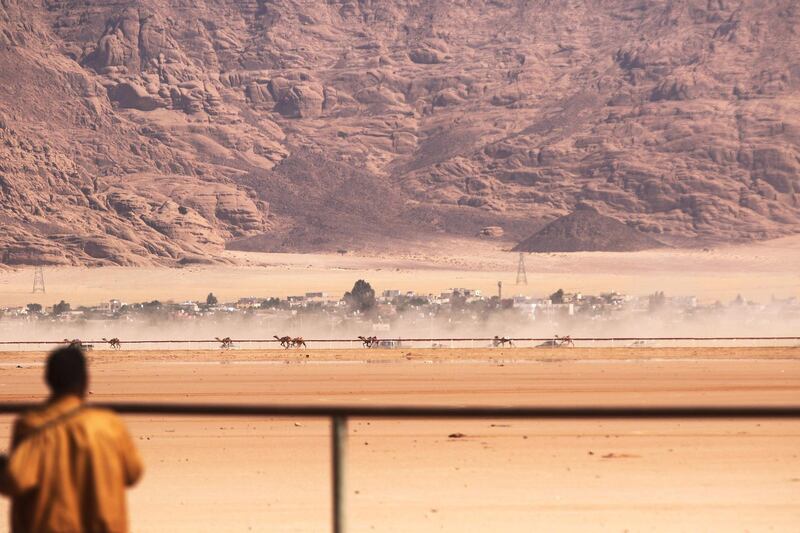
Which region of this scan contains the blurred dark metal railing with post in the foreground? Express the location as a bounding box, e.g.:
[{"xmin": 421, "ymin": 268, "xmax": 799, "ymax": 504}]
[{"xmin": 0, "ymin": 403, "xmax": 800, "ymax": 533}]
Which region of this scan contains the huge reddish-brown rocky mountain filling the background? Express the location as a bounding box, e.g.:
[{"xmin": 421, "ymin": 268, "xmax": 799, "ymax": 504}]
[{"xmin": 0, "ymin": 0, "xmax": 800, "ymax": 265}]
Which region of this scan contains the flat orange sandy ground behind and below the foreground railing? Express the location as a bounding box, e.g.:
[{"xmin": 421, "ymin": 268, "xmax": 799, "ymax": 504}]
[{"xmin": 0, "ymin": 348, "xmax": 800, "ymax": 533}]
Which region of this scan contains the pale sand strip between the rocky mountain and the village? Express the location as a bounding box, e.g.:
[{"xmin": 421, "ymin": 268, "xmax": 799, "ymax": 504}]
[{"xmin": 0, "ymin": 237, "xmax": 800, "ymax": 305}]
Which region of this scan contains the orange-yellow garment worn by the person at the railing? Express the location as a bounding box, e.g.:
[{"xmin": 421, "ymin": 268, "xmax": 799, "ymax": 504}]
[{"xmin": 0, "ymin": 396, "xmax": 143, "ymax": 533}]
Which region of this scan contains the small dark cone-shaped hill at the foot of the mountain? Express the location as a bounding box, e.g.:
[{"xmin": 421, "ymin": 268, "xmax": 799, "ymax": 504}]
[{"xmin": 514, "ymin": 206, "xmax": 664, "ymax": 252}]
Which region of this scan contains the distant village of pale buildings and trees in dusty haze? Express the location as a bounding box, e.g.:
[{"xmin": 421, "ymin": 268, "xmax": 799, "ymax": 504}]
[{"xmin": 0, "ymin": 280, "xmax": 800, "ymax": 336}]
